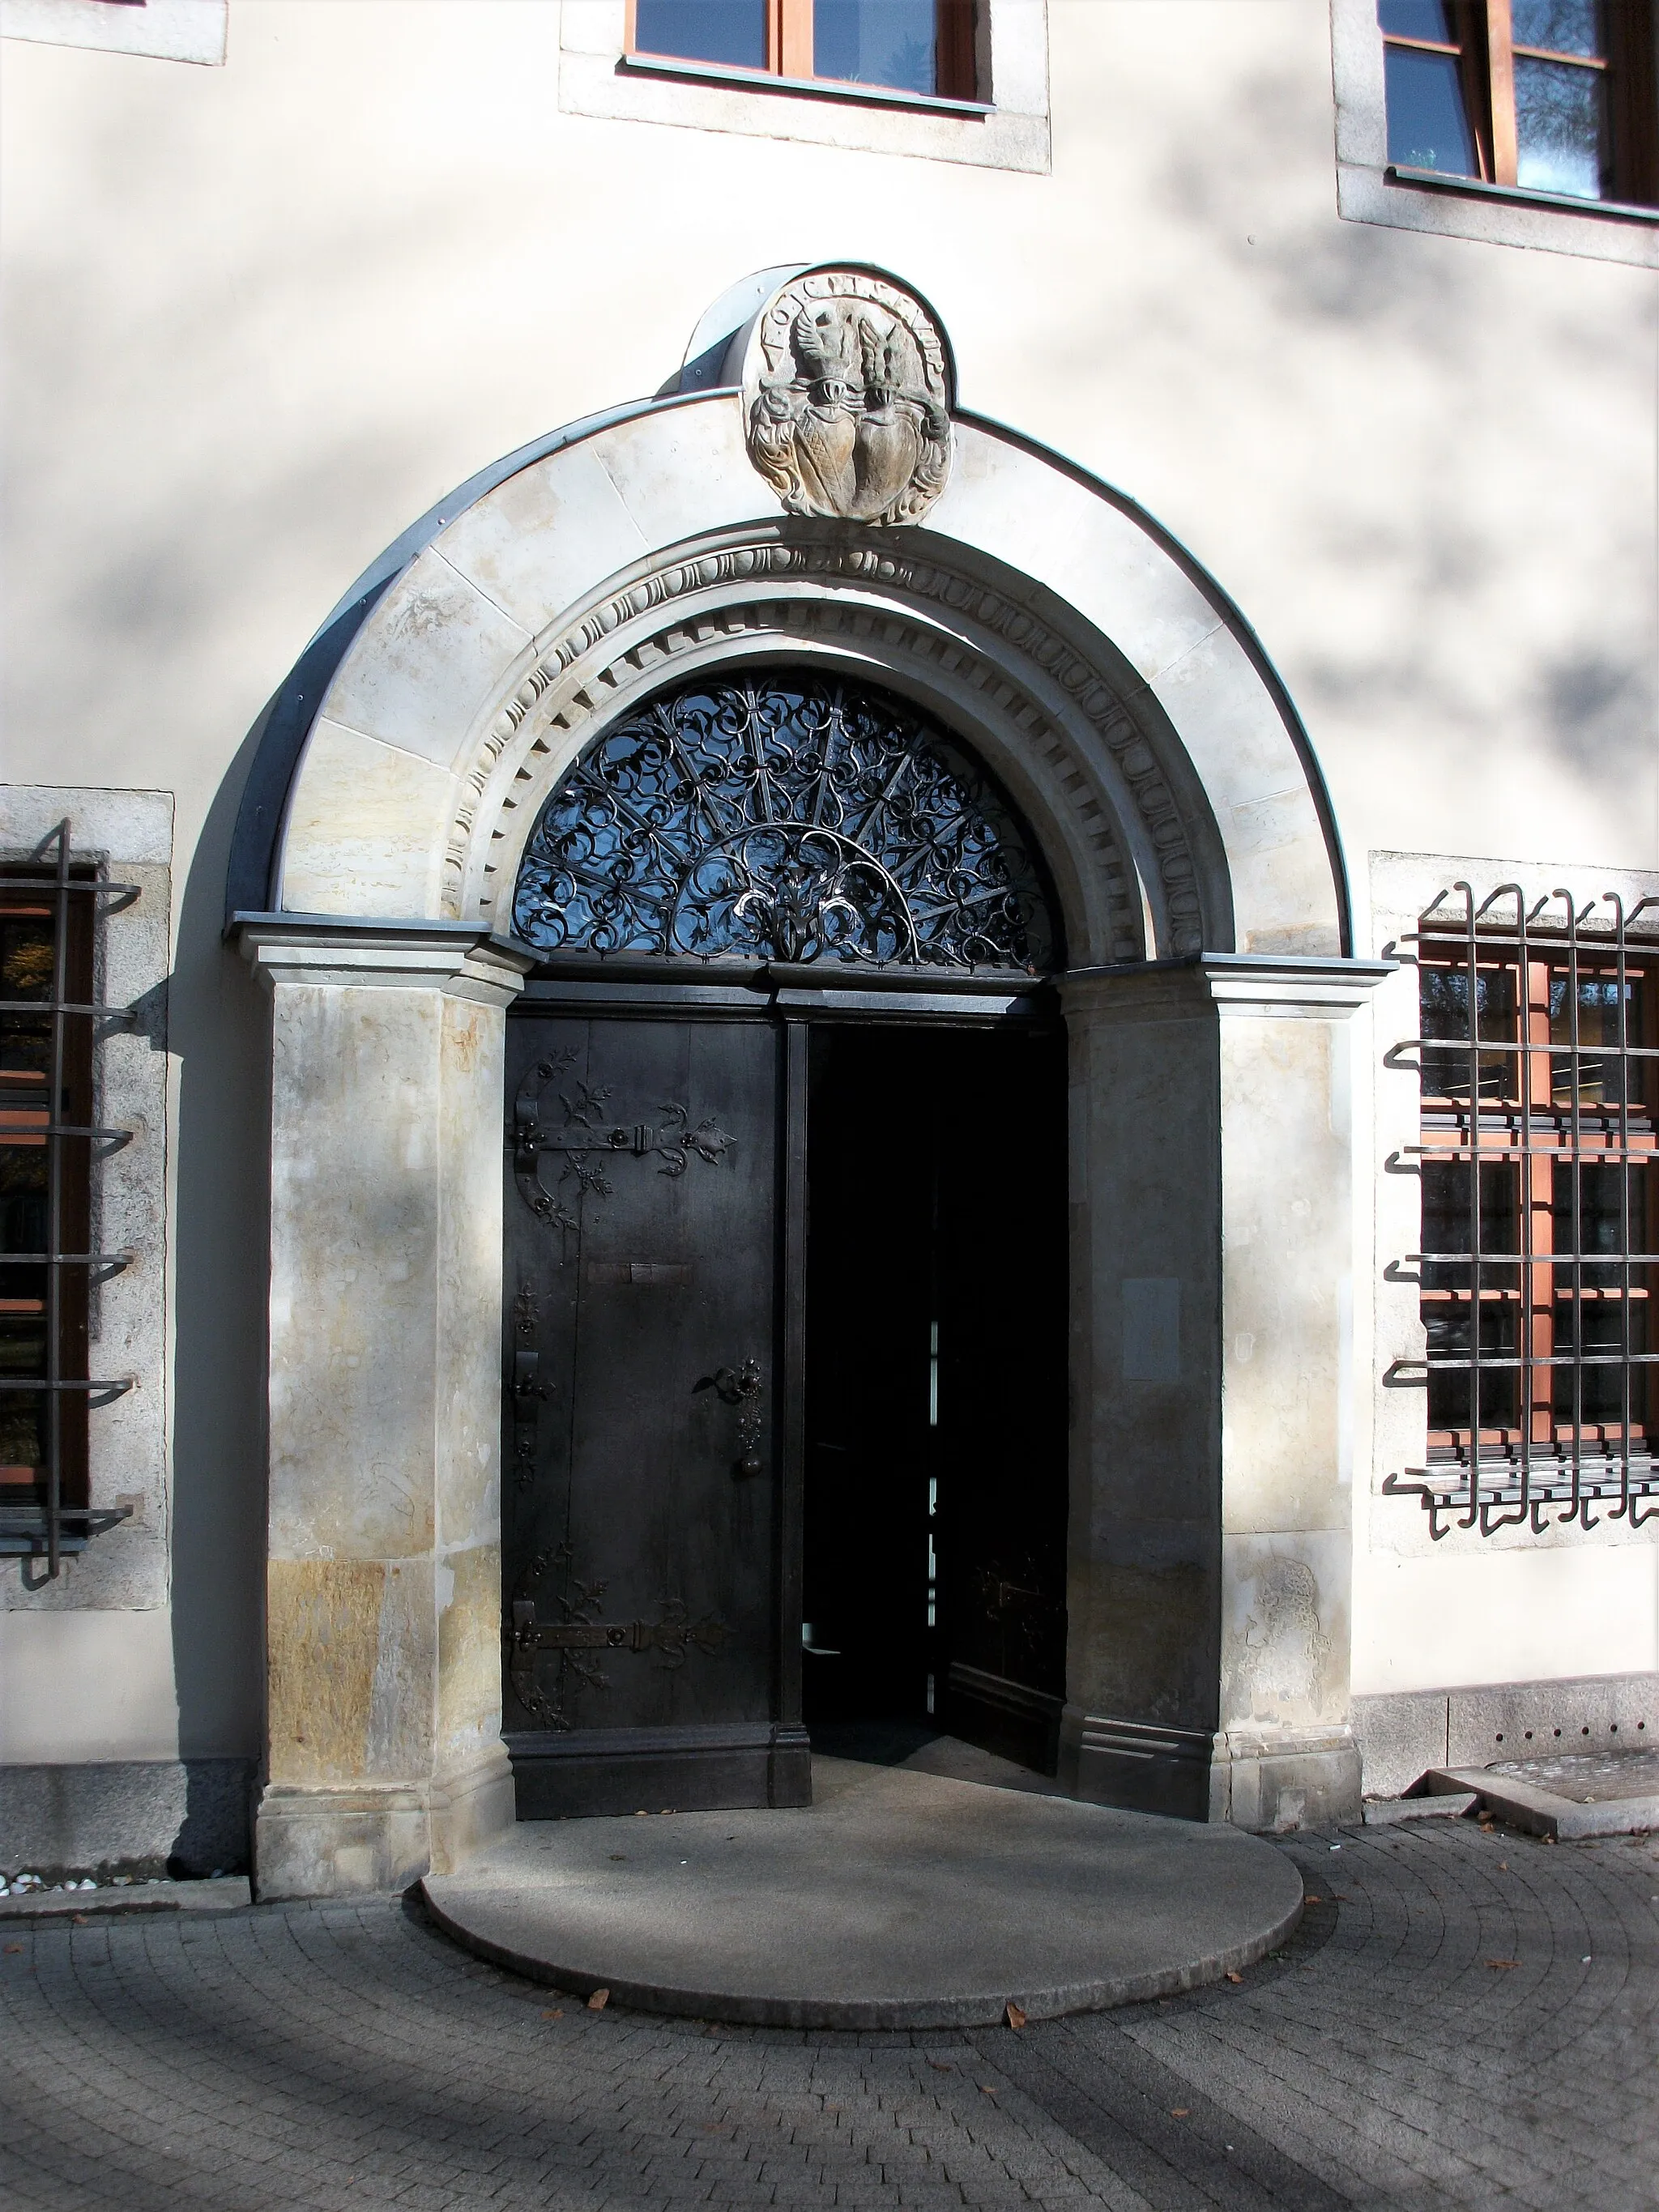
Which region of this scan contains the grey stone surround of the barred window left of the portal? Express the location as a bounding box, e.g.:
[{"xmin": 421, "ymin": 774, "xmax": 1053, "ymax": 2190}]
[{"xmin": 0, "ymin": 783, "xmax": 173, "ymax": 1613}]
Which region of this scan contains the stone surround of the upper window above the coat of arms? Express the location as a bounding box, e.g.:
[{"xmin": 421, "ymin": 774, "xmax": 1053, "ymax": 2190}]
[{"xmin": 560, "ymin": 0, "xmax": 1048, "ymax": 175}]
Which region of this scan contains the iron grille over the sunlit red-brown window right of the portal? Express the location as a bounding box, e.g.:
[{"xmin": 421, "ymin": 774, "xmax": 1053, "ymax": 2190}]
[{"xmin": 1384, "ymin": 883, "xmax": 1659, "ymax": 1537}]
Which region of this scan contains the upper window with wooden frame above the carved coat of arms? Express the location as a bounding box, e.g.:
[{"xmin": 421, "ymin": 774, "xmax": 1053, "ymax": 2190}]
[{"xmin": 626, "ymin": 0, "xmax": 978, "ymax": 100}]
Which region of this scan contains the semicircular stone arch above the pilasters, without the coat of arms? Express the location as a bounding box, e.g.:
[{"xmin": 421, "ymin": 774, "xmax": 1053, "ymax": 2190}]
[{"xmin": 234, "ymin": 391, "xmax": 1347, "ymax": 962}]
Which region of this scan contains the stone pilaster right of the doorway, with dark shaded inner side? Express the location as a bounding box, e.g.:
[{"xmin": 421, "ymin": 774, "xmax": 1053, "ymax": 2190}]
[{"xmin": 1062, "ymin": 956, "xmax": 1387, "ymax": 1830}]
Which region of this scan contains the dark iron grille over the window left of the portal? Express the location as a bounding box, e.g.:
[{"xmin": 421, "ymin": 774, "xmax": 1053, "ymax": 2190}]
[{"xmin": 0, "ymin": 820, "xmax": 139, "ymax": 1577}]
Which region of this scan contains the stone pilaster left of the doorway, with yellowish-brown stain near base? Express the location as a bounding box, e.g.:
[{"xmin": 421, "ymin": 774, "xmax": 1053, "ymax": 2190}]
[{"xmin": 239, "ymin": 916, "xmax": 531, "ymax": 1898}]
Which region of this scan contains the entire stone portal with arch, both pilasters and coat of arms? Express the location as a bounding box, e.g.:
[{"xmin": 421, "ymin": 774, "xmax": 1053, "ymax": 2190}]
[{"xmin": 230, "ymin": 267, "xmax": 1378, "ymax": 1894}]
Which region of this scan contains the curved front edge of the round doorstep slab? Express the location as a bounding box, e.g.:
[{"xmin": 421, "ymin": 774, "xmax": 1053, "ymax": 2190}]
[{"xmin": 418, "ymin": 1882, "xmax": 1303, "ymax": 2033}]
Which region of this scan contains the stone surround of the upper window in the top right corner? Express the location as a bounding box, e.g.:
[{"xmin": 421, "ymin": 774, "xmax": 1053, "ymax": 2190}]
[{"xmin": 1332, "ymin": 0, "xmax": 1659, "ymax": 267}]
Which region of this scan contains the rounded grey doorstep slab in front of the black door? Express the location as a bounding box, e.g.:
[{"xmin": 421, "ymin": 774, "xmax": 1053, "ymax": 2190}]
[{"xmin": 420, "ymin": 1756, "xmax": 1303, "ymax": 2028}]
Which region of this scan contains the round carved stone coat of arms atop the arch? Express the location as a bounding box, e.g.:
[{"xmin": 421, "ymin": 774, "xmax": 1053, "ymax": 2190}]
[{"xmin": 744, "ymin": 270, "xmax": 951, "ymax": 522}]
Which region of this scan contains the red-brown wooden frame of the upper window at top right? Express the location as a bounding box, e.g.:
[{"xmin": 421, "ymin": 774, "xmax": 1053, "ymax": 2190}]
[{"xmin": 1383, "ymin": 0, "xmax": 1659, "ymax": 208}]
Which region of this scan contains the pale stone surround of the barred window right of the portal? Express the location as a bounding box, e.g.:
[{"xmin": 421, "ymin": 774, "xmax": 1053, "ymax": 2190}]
[{"xmin": 1365, "ymin": 851, "xmax": 1659, "ymax": 1559}]
